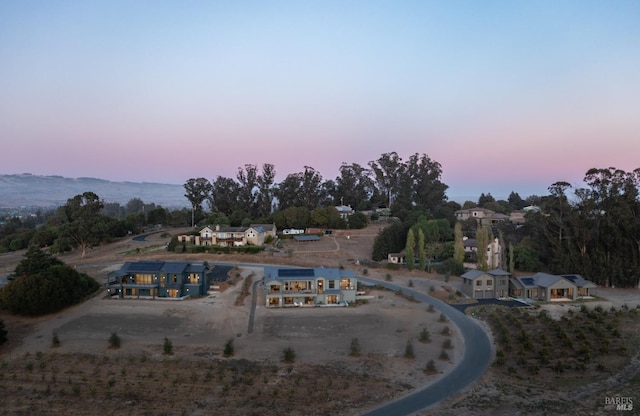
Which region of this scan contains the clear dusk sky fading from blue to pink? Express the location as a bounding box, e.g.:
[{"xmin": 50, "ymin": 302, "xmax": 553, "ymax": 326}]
[{"xmin": 0, "ymin": 0, "xmax": 640, "ymax": 199}]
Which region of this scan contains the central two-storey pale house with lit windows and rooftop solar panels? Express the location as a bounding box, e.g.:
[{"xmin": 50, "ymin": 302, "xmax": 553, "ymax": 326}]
[{"xmin": 264, "ymin": 267, "xmax": 358, "ymax": 307}]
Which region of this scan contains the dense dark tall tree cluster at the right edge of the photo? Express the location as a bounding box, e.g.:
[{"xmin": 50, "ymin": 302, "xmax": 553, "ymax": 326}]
[{"xmin": 516, "ymin": 168, "xmax": 640, "ymax": 287}]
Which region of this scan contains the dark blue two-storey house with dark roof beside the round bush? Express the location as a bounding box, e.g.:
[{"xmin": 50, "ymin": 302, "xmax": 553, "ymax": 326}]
[{"xmin": 107, "ymin": 261, "xmax": 211, "ymax": 299}]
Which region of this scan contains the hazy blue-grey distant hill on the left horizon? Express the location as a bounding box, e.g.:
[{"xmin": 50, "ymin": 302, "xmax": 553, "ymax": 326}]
[{"xmin": 0, "ymin": 173, "xmax": 189, "ymax": 208}]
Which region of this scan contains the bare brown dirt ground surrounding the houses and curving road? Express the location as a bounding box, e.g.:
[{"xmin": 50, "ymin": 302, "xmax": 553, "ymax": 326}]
[{"xmin": 0, "ymin": 224, "xmax": 640, "ymax": 416}]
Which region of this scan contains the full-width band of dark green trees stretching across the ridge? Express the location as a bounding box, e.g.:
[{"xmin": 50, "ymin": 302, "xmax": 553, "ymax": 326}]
[{"xmin": 0, "ymin": 152, "xmax": 640, "ymax": 287}]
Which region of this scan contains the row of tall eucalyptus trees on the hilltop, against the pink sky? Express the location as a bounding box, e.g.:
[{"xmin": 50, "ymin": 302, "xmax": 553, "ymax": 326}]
[{"xmin": 184, "ymin": 152, "xmax": 447, "ymax": 224}]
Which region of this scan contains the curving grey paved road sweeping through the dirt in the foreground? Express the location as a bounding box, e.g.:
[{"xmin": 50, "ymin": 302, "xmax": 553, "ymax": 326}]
[{"xmin": 358, "ymin": 277, "xmax": 492, "ymax": 416}]
